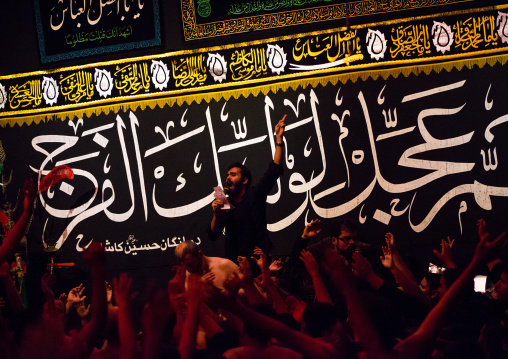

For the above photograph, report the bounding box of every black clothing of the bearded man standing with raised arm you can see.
[208,162,284,262]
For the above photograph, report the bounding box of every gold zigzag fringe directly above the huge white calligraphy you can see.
[0,54,508,127]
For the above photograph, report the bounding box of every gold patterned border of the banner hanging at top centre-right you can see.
[181,0,474,41]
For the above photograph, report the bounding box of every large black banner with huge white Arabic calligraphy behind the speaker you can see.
[0,61,508,269]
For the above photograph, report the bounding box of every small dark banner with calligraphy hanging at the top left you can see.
[35,0,161,63]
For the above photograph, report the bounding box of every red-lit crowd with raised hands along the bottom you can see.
[0,182,508,359]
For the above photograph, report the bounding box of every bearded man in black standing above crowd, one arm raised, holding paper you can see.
[208,116,285,261]
